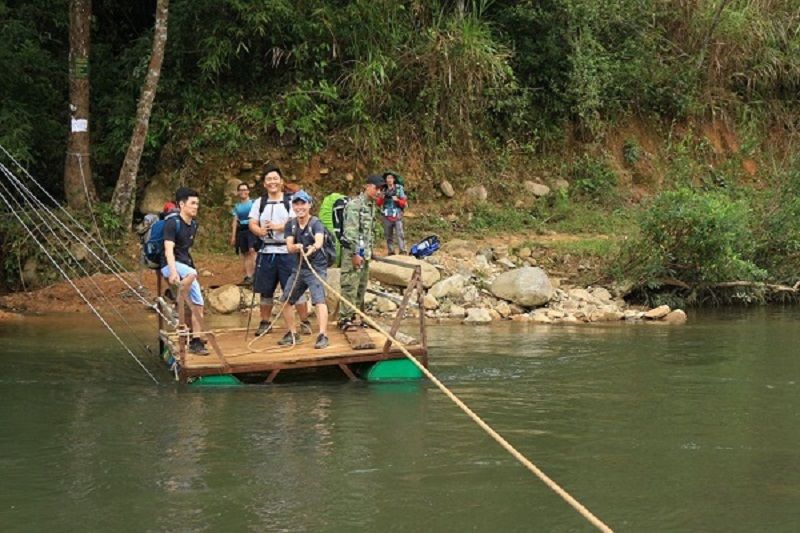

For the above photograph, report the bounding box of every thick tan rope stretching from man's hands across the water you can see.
[301,253,613,533]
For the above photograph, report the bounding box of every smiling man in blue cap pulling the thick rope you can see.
[278,191,328,349]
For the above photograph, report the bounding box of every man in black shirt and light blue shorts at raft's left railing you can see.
[161,187,209,355]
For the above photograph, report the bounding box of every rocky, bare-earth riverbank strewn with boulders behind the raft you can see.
[0,234,686,324]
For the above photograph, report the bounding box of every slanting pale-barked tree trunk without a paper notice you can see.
[111,0,169,227]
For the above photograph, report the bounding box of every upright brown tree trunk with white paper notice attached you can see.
[64,0,97,210]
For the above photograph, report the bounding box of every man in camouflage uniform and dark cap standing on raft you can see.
[339,176,386,330]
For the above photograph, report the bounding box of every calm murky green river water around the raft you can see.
[0,308,800,532]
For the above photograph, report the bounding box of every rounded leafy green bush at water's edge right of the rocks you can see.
[621,187,767,285]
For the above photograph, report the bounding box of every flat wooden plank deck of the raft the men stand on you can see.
[161,328,428,383]
